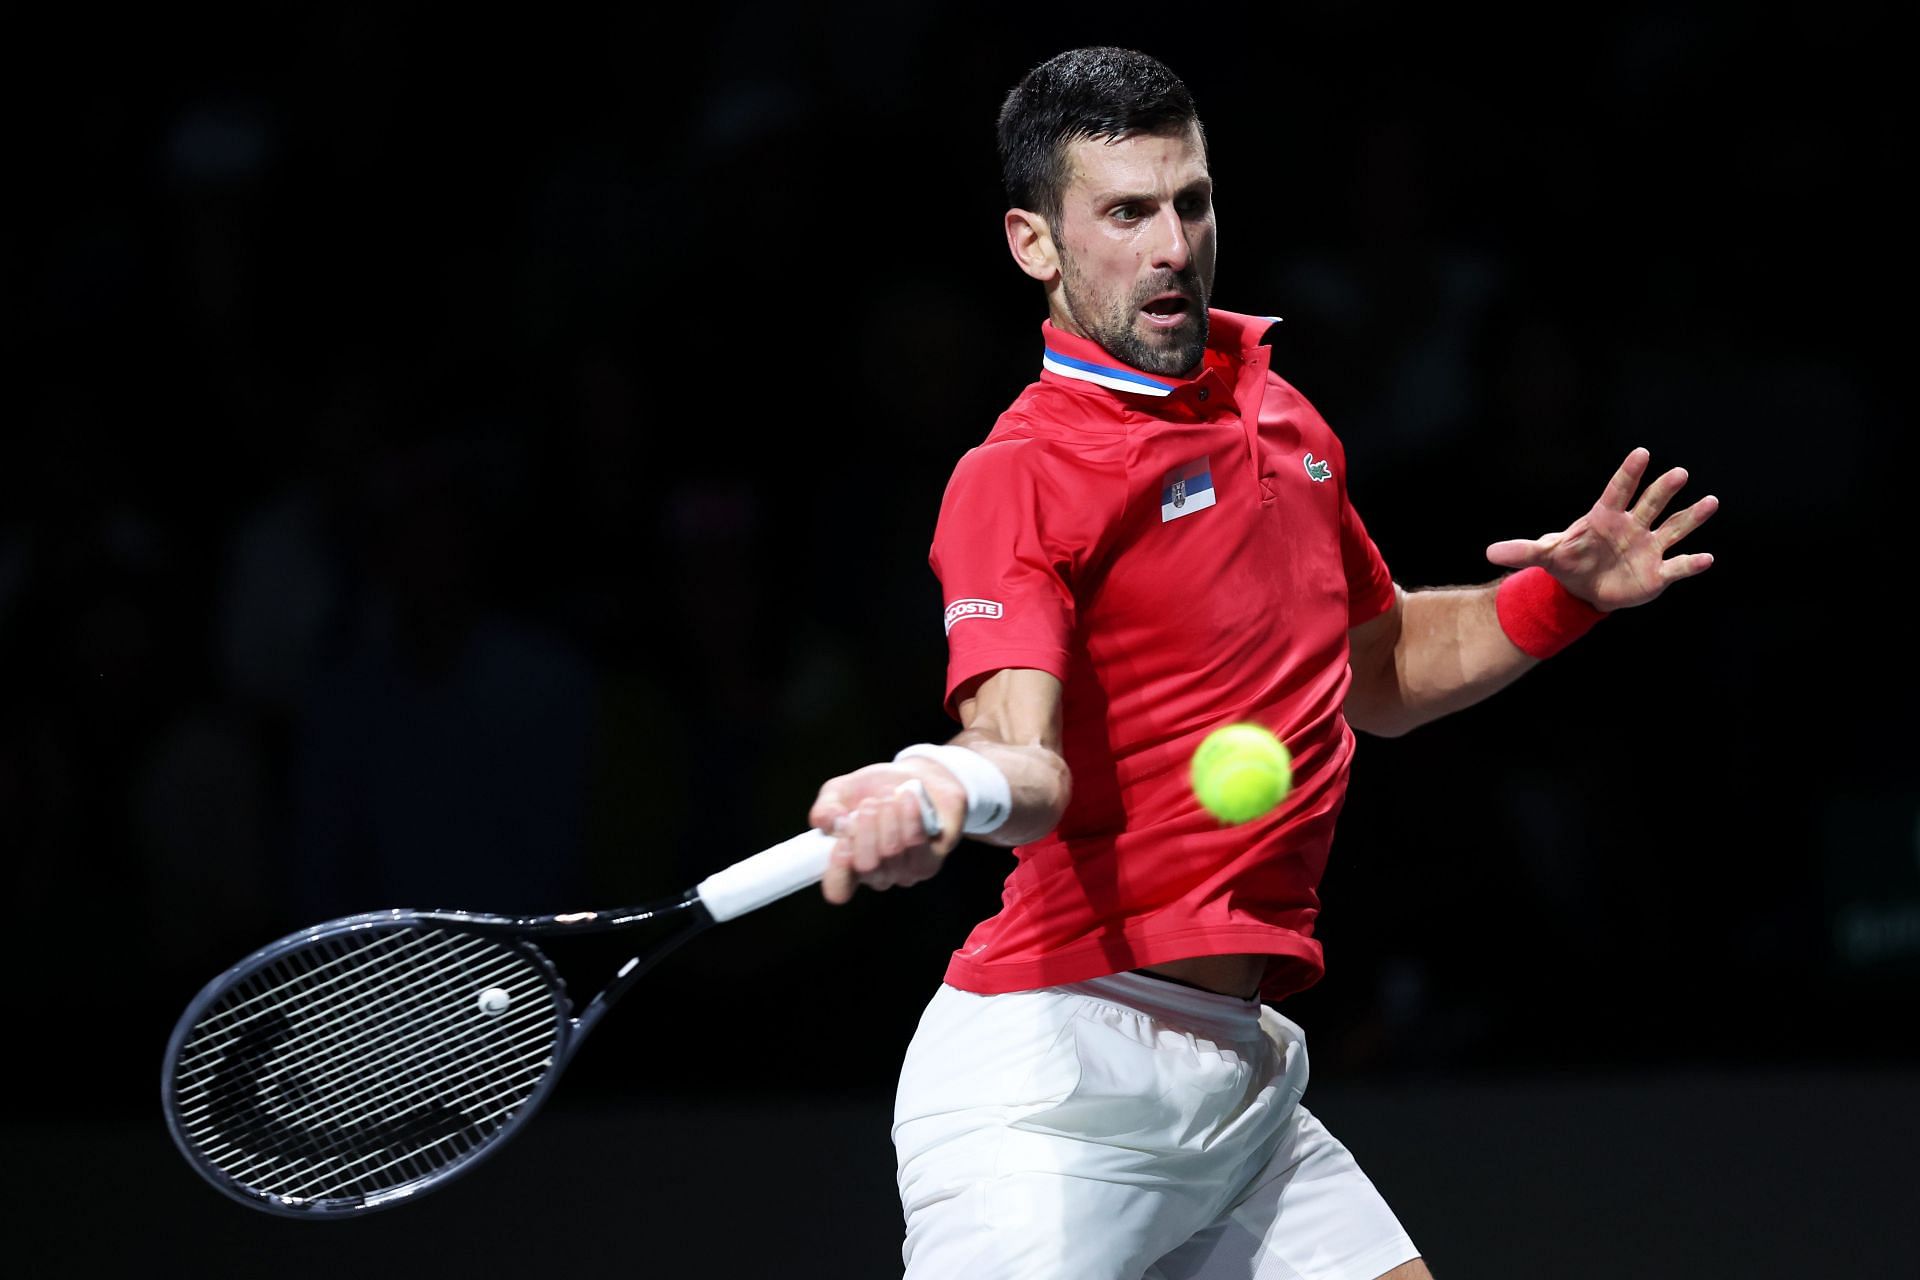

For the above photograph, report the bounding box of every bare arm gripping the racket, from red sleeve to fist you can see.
[808,668,1071,902]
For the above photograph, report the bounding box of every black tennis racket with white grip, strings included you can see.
[161,783,939,1219]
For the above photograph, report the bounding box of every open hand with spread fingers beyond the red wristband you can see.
[1486,449,1720,610]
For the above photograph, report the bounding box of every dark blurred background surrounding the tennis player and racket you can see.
[0,4,1920,1276]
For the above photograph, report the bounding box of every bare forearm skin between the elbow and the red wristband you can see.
[1365,583,1538,737]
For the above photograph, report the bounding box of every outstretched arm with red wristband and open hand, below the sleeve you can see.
[1346,449,1720,737]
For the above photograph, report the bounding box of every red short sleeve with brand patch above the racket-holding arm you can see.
[929,439,1096,718]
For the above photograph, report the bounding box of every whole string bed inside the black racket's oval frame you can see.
[175,927,564,1201]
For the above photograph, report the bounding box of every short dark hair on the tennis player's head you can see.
[1000,46,1206,223]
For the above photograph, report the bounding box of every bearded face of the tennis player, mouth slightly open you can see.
[1054,127,1215,376]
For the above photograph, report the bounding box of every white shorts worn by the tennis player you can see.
[893,973,1419,1280]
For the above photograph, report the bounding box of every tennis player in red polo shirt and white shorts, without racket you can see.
[810,48,1716,1280]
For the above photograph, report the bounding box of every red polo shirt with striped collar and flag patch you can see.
[931,311,1394,1000]
